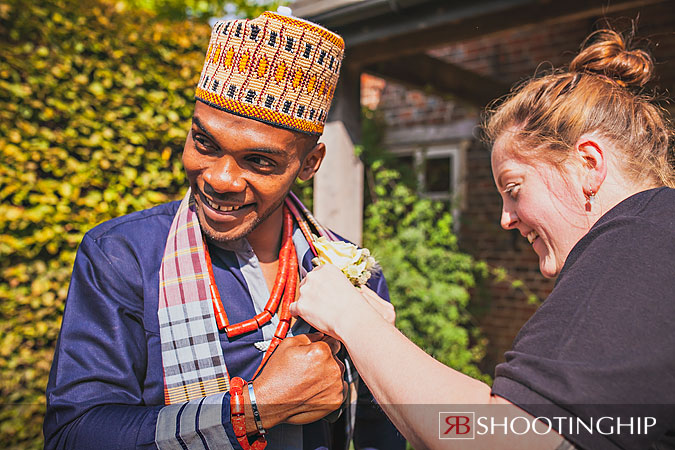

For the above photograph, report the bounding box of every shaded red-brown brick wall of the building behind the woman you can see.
[362,3,675,372]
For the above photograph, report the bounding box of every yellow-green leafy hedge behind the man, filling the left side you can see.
[0,0,210,449]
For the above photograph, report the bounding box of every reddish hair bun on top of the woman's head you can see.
[570,30,654,86]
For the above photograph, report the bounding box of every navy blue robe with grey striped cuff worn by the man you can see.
[44,202,405,450]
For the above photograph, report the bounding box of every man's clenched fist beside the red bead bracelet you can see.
[252,333,347,431]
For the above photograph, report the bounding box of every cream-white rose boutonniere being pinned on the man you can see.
[312,236,377,287]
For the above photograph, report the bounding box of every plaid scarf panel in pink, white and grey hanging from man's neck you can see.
[157,189,230,405]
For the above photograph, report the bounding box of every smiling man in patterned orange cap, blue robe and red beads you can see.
[44,13,404,449]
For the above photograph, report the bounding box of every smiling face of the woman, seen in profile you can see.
[492,136,590,278]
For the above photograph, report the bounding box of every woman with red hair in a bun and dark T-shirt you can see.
[293,30,675,449]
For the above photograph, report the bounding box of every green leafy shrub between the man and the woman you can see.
[357,108,499,383]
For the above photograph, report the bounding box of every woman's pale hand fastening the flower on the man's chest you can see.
[290,264,395,339]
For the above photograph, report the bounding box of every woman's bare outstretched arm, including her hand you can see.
[291,265,562,449]
